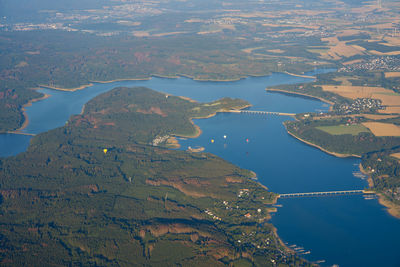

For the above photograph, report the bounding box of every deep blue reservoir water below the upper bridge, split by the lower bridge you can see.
[180,114,400,266]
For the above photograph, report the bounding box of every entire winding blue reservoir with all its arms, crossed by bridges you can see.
[0,73,400,266]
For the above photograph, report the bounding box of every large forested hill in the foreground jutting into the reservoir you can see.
[0,88,306,266]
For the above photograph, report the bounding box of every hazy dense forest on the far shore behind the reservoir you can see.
[0,27,332,132]
